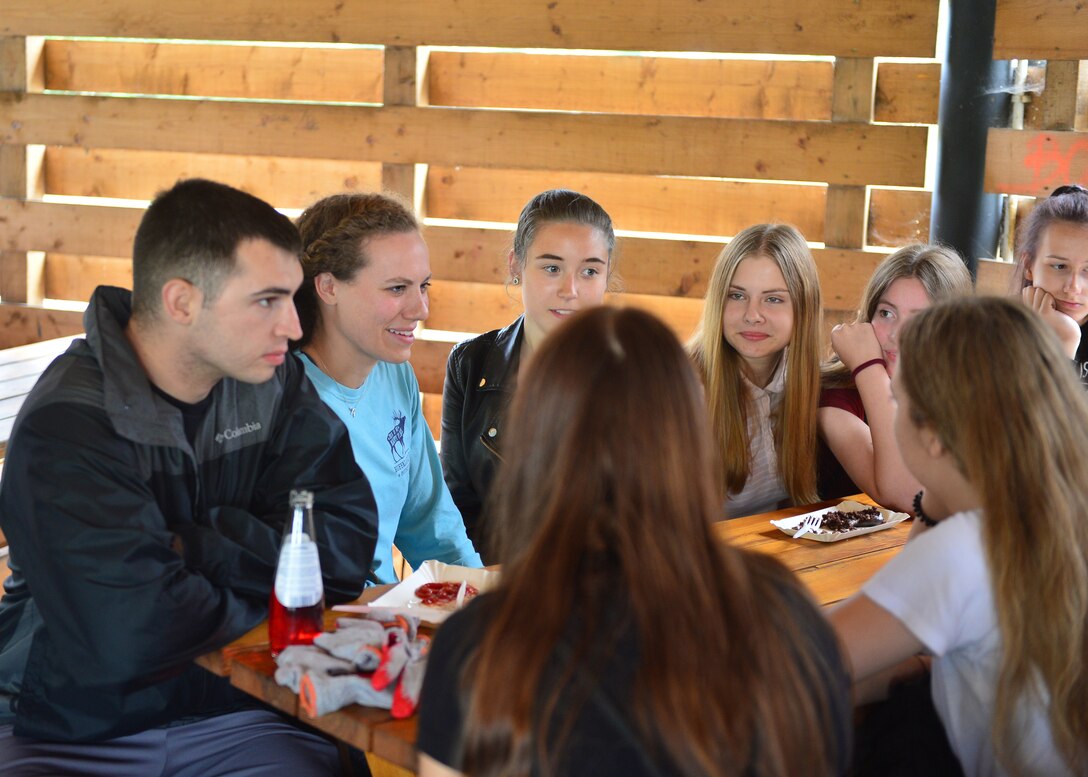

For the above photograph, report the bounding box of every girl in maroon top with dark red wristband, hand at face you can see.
[816,243,972,510]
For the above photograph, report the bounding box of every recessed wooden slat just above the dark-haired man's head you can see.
[45,146,382,208]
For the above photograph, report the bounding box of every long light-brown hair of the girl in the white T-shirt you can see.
[900,297,1088,774]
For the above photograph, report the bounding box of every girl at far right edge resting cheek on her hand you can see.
[1012,184,1088,385]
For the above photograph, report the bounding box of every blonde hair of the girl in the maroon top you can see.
[820,243,974,389]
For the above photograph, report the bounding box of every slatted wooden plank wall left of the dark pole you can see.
[0,0,970,435]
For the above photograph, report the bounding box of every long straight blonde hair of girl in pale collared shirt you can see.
[688,224,823,504]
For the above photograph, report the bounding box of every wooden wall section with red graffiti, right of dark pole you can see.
[985,0,1088,291]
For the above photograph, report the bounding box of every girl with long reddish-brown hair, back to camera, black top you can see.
[419,307,850,777]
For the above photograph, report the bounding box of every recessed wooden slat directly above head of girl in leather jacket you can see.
[424,165,826,242]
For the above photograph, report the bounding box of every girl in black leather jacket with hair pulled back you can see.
[442,189,616,564]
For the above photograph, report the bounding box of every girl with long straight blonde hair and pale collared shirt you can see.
[689,224,821,518]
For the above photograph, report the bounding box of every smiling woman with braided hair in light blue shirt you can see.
[295,194,481,583]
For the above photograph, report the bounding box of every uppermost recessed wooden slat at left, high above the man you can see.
[44,40,382,102]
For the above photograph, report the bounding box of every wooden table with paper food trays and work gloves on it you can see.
[198,497,911,775]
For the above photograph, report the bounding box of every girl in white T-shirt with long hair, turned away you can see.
[831,297,1088,777]
